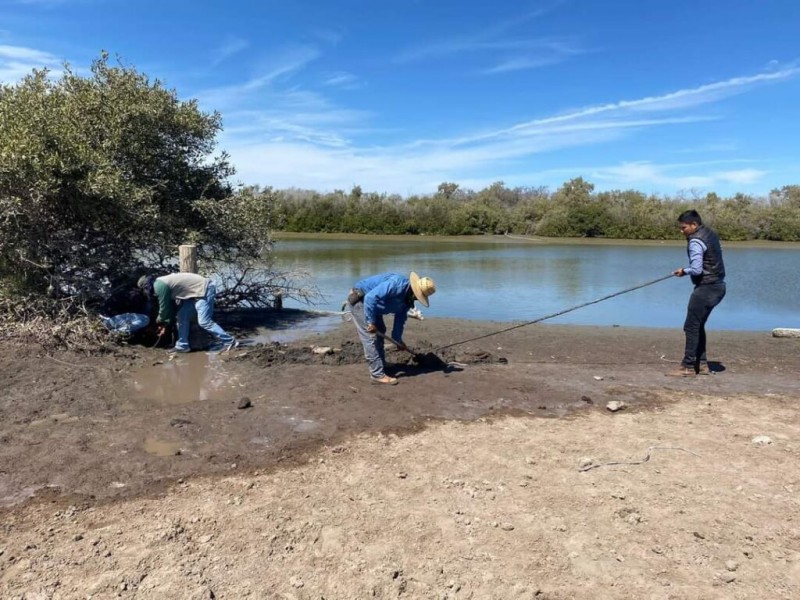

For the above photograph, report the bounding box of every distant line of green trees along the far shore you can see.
[272,177,800,241]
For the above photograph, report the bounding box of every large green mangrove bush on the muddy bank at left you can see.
[0,54,296,346]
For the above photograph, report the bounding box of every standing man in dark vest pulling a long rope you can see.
[671,210,725,377]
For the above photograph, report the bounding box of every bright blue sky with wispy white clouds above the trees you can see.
[0,0,800,195]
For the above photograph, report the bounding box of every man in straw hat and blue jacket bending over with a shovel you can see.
[347,272,436,385]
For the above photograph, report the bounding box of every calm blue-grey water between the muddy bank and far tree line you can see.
[275,237,800,330]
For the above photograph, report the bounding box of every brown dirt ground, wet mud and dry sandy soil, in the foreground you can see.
[0,312,800,600]
